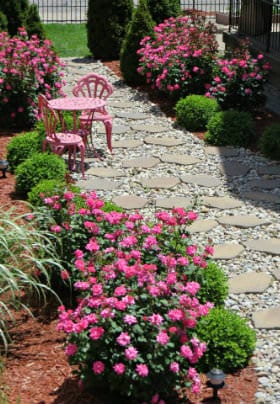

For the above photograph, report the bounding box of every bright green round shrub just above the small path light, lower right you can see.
[196,307,256,373]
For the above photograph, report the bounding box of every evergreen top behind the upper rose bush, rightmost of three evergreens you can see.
[147,0,181,25]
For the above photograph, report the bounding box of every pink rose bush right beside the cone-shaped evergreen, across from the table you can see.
[137,14,218,98]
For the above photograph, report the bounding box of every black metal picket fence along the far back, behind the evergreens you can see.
[29,0,230,23]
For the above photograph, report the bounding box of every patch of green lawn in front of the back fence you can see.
[44,24,90,57]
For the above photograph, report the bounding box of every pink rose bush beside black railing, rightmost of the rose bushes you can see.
[206,41,271,111]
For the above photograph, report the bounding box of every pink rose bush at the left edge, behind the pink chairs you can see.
[0,28,63,129]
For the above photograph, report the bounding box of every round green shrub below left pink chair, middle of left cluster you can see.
[15,153,66,196]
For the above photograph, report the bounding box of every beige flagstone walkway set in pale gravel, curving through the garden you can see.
[62,59,280,403]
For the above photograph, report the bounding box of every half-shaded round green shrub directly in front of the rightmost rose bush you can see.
[205,109,255,147]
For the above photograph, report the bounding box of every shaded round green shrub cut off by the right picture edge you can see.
[259,123,280,160]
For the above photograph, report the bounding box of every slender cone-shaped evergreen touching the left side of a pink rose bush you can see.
[120,0,155,84]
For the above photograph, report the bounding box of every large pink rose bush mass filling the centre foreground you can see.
[32,192,217,402]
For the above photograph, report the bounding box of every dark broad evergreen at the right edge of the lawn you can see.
[87,0,133,60]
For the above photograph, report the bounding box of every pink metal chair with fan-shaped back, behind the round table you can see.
[72,73,114,153]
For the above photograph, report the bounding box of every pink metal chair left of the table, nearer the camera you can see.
[38,94,85,178]
